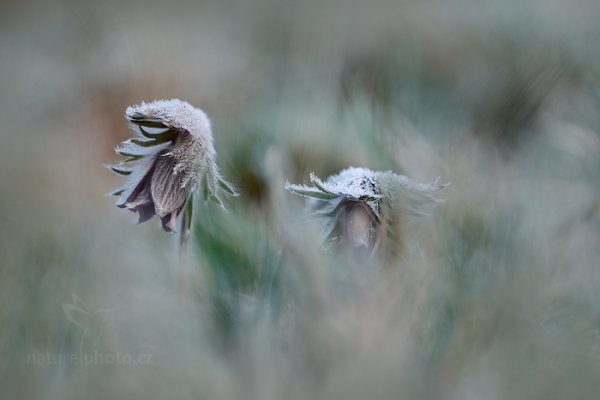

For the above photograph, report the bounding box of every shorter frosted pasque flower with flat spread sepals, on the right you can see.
[285,167,448,255]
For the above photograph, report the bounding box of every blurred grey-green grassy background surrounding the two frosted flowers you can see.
[0,0,600,399]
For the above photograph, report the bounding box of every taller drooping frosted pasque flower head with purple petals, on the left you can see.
[110,99,237,232]
